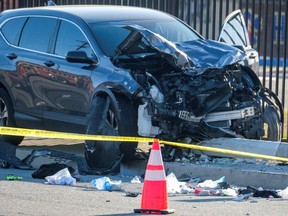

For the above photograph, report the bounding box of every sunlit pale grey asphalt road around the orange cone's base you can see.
[0,174,288,216]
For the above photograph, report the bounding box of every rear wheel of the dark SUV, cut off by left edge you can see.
[0,88,24,145]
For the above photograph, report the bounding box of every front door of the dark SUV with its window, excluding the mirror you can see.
[41,20,95,132]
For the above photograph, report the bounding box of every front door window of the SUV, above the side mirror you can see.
[55,21,94,58]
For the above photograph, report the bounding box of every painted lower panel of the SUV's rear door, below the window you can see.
[1,47,45,128]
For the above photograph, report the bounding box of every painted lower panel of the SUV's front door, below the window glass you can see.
[41,57,92,130]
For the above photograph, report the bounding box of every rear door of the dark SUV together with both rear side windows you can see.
[3,16,57,128]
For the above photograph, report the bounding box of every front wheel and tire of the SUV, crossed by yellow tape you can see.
[85,96,137,169]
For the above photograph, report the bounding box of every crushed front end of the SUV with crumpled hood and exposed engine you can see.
[113,26,281,141]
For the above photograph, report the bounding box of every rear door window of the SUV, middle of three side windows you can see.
[19,17,57,52]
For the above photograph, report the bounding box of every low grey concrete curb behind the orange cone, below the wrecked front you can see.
[121,161,288,190]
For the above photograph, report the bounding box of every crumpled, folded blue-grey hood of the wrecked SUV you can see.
[113,25,245,75]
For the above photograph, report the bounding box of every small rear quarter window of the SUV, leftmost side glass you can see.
[1,17,27,45]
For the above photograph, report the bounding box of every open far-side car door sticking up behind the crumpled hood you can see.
[218,10,259,72]
